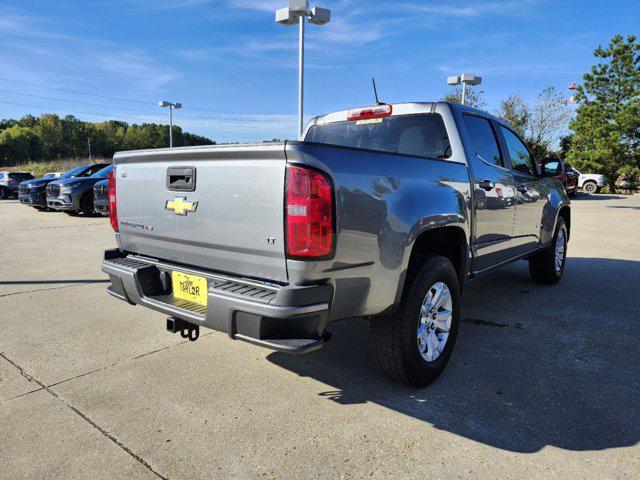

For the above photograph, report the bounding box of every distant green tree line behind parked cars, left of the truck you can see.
[0,114,215,166]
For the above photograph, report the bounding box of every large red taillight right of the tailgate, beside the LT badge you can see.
[285,165,334,259]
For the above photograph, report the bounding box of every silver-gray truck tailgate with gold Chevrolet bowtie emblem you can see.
[115,144,287,282]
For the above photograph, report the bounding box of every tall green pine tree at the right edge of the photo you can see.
[569,35,640,192]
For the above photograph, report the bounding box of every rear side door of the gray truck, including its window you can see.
[463,114,516,272]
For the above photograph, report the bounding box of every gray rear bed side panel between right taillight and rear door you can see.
[286,143,471,320]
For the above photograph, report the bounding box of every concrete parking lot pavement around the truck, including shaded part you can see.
[0,195,640,479]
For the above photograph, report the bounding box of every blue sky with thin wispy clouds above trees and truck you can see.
[0,0,640,141]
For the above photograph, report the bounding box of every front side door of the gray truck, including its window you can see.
[500,125,549,255]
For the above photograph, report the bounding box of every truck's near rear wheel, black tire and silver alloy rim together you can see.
[370,256,460,388]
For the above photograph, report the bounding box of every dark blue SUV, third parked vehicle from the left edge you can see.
[47,163,112,215]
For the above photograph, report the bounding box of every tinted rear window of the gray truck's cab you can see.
[306,114,451,159]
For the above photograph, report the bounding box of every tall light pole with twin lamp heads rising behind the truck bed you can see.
[276,0,331,140]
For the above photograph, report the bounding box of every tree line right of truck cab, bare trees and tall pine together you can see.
[444,35,640,192]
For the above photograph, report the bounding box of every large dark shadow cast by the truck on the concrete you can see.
[268,258,640,453]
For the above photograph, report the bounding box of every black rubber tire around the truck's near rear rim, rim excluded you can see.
[369,255,460,388]
